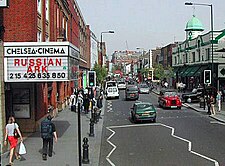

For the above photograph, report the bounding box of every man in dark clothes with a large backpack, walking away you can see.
[41,113,58,160]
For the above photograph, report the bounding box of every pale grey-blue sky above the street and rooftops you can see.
[77,0,225,55]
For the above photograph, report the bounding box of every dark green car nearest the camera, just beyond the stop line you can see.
[131,102,156,123]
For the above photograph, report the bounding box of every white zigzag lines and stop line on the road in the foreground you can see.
[106,123,219,166]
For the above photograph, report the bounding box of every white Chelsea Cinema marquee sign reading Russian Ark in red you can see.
[4,42,79,82]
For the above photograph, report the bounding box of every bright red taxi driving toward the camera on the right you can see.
[158,90,182,109]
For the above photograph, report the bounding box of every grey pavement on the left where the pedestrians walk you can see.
[2,100,105,166]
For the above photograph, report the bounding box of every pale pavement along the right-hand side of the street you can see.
[152,88,225,123]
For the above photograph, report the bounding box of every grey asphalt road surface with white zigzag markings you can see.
[99,91,225,166]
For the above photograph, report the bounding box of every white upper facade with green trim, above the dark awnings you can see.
[172,31,225,67]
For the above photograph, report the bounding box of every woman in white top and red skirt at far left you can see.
[4,116,23,165]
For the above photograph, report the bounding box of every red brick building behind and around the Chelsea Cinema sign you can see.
[0,0,90,151]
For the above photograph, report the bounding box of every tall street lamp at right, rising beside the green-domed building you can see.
[185,2,214,86]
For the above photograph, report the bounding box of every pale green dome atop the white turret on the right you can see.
[185,15,204,31]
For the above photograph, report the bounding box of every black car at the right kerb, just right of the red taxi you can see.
[182,88,204,102]
